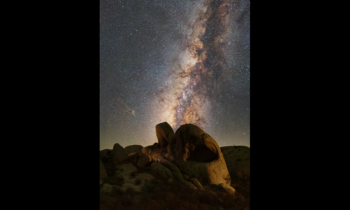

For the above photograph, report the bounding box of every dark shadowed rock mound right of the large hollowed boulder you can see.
[221,146,250,177]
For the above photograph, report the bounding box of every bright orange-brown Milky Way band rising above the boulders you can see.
[157,0,231,130]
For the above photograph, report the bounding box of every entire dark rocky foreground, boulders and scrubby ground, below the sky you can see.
[100,122,250,210]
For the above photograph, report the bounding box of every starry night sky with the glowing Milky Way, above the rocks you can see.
[100,0,250,150]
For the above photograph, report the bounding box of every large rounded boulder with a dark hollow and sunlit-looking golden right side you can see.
[174,124,231,185]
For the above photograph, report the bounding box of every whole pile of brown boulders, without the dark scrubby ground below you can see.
[100,122,243,193]
